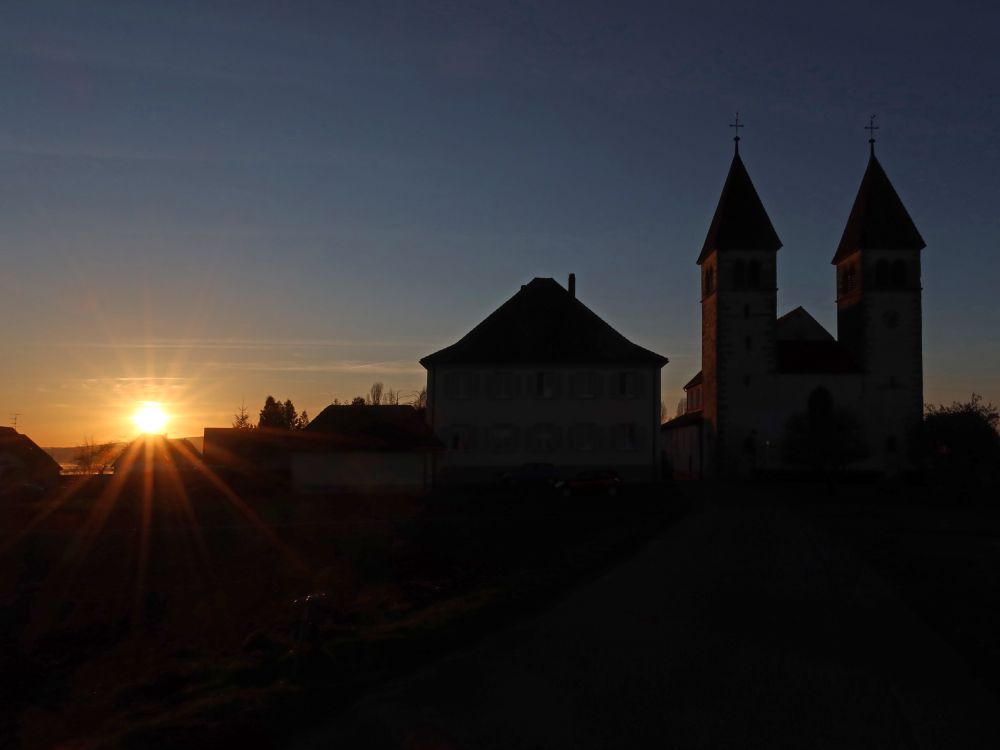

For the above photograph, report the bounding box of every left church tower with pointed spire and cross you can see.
[698,133,781,475]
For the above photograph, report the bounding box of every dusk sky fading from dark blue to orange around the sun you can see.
[0,0,1000,446]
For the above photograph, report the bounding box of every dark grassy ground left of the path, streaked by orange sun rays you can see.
[0,477,685,747]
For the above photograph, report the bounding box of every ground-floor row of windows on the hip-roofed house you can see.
[448,422,642,453]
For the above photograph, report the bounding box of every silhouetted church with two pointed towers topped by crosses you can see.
[661,128,924,478]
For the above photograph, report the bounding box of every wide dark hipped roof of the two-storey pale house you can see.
[420,279,667,367]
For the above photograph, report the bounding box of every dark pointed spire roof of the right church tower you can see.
[832,151,926,263]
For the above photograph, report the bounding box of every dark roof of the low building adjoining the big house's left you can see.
[304,405,443,451]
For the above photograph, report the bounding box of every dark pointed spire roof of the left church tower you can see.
[698,153,781,265]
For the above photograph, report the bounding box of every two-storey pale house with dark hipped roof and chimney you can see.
[420,274,667,482]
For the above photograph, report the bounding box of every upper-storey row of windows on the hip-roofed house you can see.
[444,370,644,399]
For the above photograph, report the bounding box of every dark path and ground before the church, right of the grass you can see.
[295,486,1000,748]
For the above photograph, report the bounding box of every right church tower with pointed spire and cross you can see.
[832,131,925,463]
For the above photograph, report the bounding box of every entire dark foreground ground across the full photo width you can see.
[0,484,1000,748]
